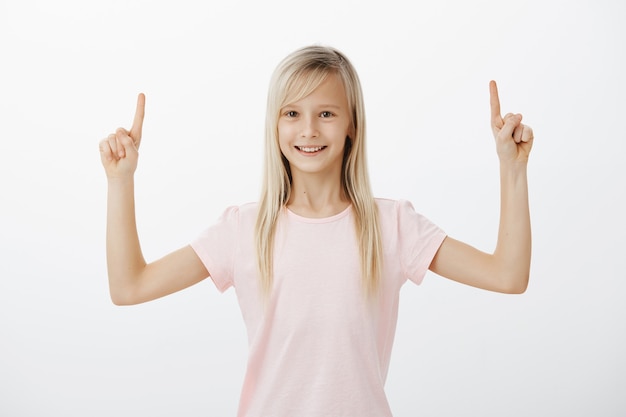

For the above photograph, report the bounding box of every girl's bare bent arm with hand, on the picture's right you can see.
[430,81,533,294]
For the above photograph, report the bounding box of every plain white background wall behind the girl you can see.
[0,0,626,417]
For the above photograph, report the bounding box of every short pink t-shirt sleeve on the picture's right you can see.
[396,200,446,284]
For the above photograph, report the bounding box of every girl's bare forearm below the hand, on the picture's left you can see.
[106,177,146,303]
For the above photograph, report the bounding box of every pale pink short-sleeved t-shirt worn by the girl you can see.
[192,199,445,417]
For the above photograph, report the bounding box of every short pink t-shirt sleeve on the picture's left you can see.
[191,207,239,292]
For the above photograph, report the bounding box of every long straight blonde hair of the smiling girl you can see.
[255,46,382,295]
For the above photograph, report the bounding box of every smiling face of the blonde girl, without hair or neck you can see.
[278,74,352,180]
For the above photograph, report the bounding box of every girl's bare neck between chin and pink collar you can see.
[287,174,350,218]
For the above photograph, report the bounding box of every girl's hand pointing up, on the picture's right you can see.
[489,81,533,163]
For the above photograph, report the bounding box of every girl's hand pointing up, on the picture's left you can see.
[100,94,146,178]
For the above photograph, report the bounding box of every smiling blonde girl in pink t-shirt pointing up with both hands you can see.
[100,46,533,417]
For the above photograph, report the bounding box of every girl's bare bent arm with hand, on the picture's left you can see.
[100,94,209,305]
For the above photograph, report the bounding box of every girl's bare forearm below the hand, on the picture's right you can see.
[494,163,532,292]
